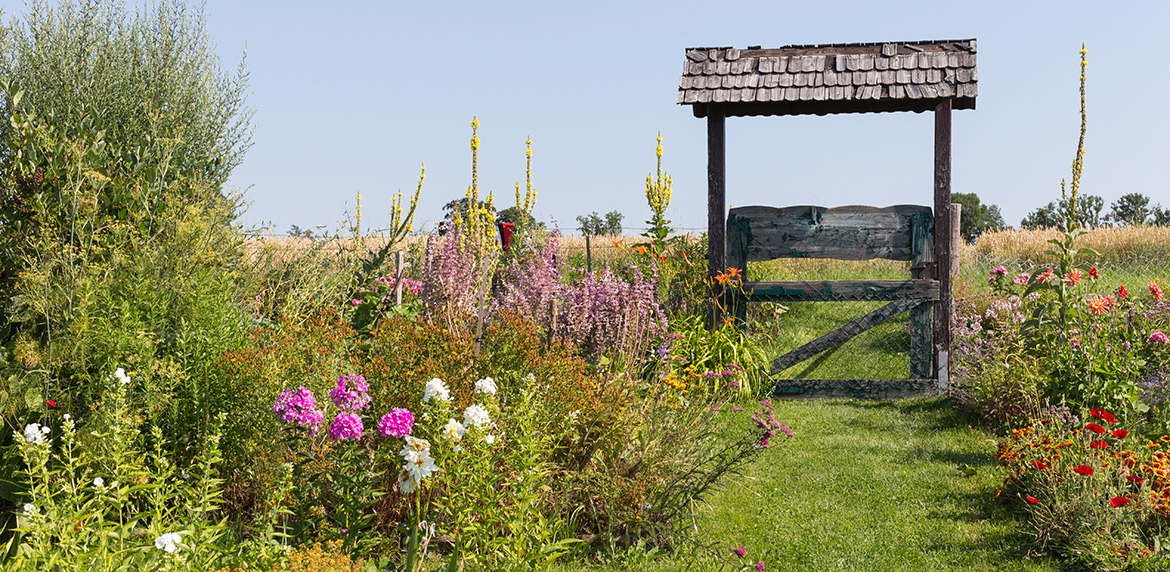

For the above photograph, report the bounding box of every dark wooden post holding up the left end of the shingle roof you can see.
[707,105,727,328]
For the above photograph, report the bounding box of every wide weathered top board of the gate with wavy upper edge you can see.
[728,205,930,261]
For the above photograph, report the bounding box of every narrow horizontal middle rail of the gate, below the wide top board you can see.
[744,277,938,302]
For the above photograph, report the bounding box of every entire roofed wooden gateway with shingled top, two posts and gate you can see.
[677,39,978,398]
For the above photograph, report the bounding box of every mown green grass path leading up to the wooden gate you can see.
[563,398,1059,572]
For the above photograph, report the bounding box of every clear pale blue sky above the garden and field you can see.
[11,0,1170,233]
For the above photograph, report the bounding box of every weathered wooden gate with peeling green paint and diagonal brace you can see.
[724,205,940,398]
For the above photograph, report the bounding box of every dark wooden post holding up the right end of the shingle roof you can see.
[934,99,952,385]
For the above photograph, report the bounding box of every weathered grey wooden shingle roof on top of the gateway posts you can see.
[679,40,978,117]
